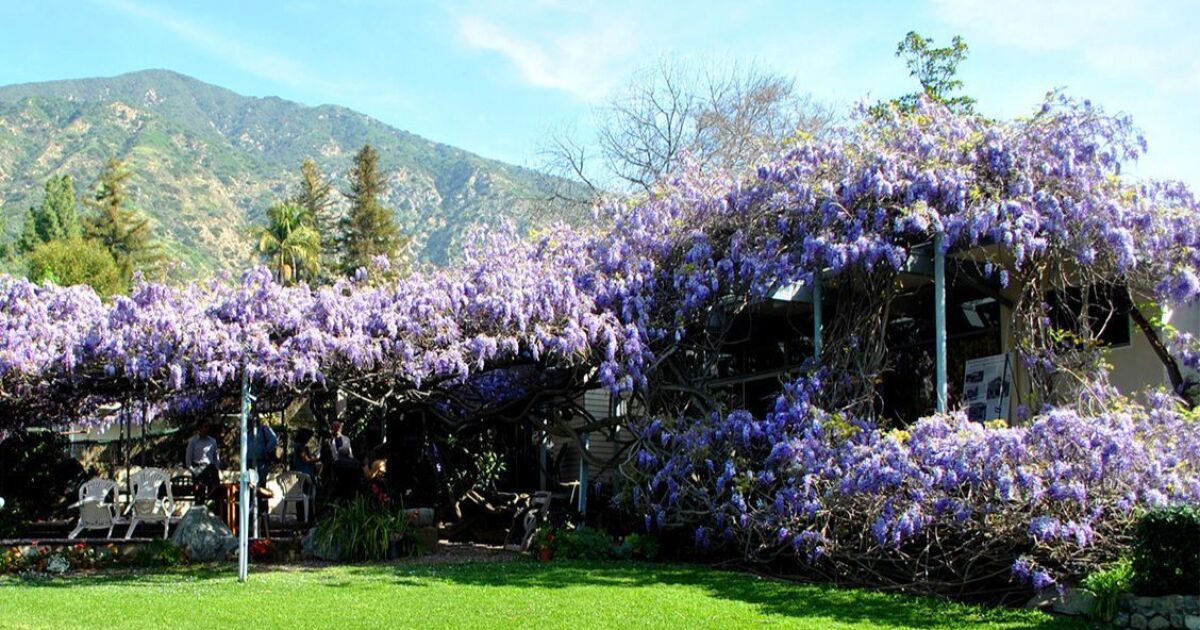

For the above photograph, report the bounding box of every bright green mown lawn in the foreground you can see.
[0,560,1076,630]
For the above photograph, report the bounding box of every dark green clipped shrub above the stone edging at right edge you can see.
[1133,505,1200,595]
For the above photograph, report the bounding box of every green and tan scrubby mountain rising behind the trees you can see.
[0,70,554,274]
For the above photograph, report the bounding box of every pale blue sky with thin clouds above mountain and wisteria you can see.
[0,0,1200,187]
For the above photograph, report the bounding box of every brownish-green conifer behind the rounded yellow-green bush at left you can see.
[84,158,160,278]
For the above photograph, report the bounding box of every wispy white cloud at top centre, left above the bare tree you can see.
[457,0,641,101]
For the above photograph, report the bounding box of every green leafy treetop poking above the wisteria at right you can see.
[895,31,976,113]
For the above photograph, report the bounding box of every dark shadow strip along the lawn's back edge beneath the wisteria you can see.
[0,560,1087,630]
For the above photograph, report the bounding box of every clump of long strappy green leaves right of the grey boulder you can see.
[314,497,409,562]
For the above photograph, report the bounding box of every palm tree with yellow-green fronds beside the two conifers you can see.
[258,203,320,284]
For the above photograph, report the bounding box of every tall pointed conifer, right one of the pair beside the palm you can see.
[341,144,403,274]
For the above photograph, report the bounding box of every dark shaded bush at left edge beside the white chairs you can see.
[0,431,86,538]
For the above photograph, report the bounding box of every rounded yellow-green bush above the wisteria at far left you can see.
[26,238,128,296]
